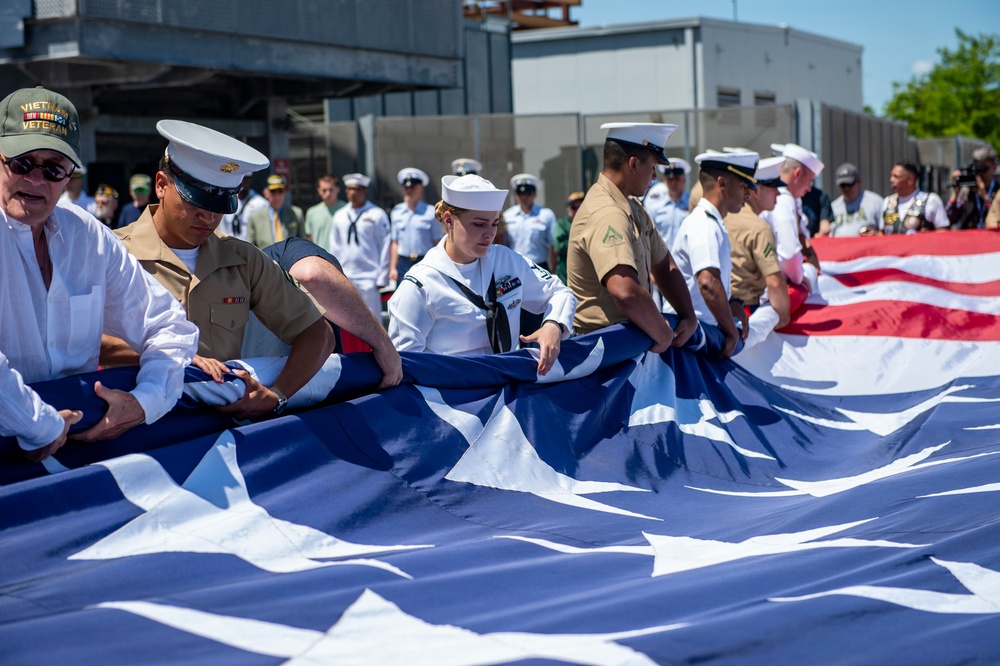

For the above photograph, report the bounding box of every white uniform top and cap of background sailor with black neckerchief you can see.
[329,174,391,316]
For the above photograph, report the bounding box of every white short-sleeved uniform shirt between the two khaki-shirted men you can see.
[670,197,733,325]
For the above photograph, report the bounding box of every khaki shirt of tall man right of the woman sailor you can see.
[566,174,667,333]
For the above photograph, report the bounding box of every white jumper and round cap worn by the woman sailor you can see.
[389,175,576,356]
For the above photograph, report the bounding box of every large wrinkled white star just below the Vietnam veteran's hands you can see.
[69,430,432,578]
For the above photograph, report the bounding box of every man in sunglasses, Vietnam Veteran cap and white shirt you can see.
[0,87,198,462]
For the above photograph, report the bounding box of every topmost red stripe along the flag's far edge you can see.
[812,229,1000,262]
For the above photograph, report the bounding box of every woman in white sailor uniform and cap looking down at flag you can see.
[389,175,576,374]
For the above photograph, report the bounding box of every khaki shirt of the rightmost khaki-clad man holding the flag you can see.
[726,204,781,305]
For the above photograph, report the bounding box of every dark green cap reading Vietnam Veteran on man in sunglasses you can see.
[0,86,83,167]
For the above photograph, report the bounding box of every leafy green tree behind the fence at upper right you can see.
[883,28,1000,149]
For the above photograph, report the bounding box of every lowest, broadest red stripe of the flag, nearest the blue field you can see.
[780,301,1000,340]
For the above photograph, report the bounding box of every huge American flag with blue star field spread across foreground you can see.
[0,232,1000,665]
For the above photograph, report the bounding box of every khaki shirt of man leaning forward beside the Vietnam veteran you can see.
[115,205,323,361]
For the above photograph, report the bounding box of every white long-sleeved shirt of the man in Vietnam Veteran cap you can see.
[0,203,198,450]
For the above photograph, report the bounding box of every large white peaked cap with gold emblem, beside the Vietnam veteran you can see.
[156,120,270,189]
